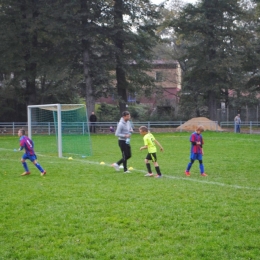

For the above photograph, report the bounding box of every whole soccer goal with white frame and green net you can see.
[27,104,92,157]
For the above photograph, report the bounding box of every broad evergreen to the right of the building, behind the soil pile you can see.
[168,0,249,120]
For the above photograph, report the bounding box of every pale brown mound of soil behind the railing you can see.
[177,117,223,131]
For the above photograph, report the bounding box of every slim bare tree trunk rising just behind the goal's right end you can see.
[83,50,96,118]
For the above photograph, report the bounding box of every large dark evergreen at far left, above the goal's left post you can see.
[0,0,80,121]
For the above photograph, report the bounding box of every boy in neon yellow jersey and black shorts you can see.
[139,126,163,178]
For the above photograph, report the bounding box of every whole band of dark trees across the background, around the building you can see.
[0,0,260,121]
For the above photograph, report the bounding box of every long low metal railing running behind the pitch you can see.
[0,121,260,135]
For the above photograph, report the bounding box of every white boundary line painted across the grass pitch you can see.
[0,148,260,191]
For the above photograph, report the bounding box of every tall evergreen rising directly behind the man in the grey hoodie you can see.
[112,0,159,112]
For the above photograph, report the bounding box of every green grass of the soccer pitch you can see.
[0,132,260,260]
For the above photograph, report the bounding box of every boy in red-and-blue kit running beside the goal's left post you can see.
[18,129,46,176]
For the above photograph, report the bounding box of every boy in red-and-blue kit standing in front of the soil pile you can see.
[185,126,207,176]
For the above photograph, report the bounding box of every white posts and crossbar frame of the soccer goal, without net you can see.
[27,104,84,158]
